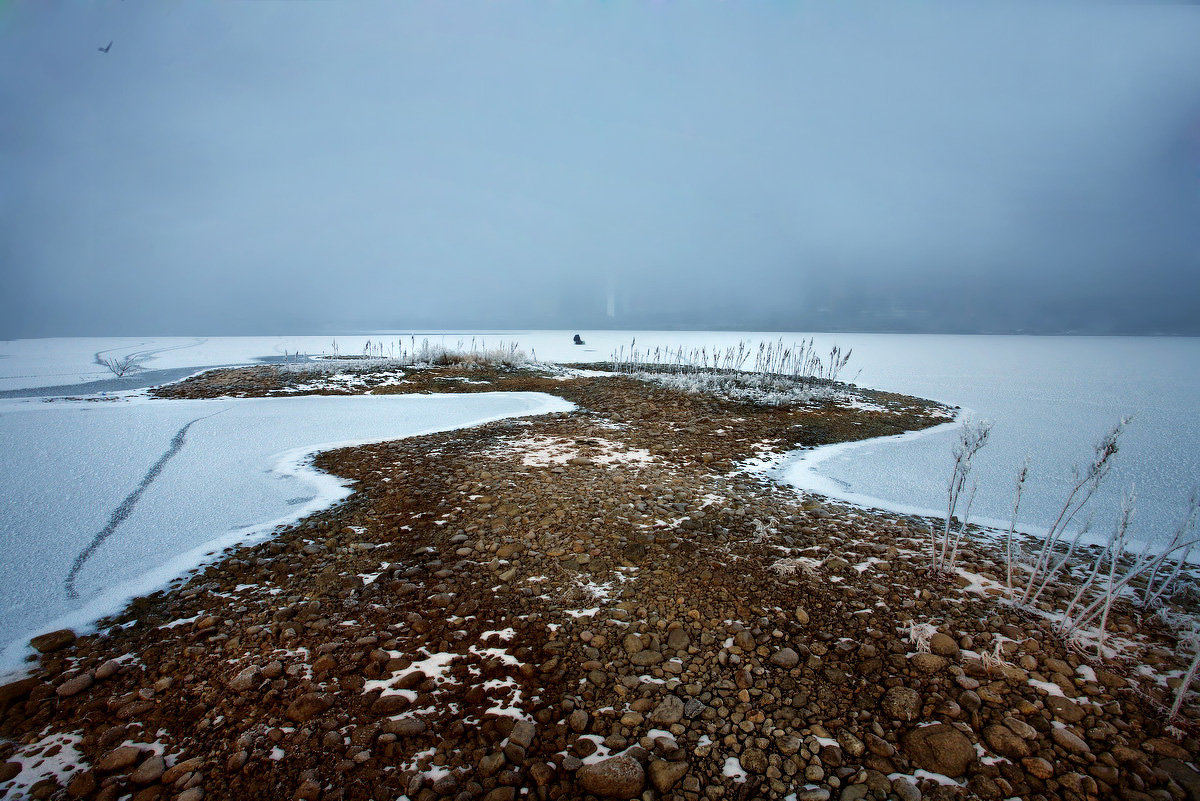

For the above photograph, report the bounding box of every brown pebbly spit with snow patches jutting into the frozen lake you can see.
[0,367,1200,801]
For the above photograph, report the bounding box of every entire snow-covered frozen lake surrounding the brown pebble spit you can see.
[0,331,1200,667]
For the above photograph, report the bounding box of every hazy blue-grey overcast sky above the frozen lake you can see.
[0,0,1200,338]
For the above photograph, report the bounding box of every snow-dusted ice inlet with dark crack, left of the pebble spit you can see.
[0,393,572,670]
